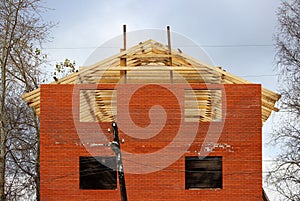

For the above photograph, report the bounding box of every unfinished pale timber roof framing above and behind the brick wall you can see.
[22,40,280,122]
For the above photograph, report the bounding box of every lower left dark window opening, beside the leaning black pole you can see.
[79,156,117,189]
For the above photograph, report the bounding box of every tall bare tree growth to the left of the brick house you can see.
[0,0,52,201]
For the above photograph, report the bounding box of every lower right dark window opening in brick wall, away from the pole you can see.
[185,156,222,189]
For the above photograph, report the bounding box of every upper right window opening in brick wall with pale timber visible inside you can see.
[184,89,222,122]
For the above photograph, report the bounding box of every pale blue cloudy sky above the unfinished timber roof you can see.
[43,0,280,198]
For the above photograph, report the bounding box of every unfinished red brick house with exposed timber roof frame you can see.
[23,35,279,201]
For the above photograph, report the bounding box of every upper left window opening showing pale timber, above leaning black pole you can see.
[79,89,117,122]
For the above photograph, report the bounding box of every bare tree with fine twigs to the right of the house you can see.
[267,0,300,201]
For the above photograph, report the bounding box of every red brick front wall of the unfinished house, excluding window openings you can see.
[40,84,262,201]
